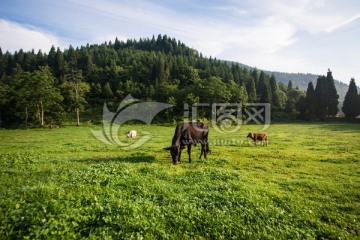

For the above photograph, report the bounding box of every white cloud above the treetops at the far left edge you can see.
[0,19,60,52]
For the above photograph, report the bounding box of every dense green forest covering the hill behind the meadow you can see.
[0,35,358,126]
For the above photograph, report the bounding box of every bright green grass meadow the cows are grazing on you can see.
[0,123,360,239]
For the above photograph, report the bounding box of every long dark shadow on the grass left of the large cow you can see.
[73,153,155,163]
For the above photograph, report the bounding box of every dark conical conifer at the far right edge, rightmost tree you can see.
[342,78,360,120]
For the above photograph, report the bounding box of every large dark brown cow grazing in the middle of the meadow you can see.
[164,122,210,164]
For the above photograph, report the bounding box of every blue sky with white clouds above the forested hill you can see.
[0,0,360,86]
